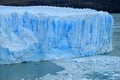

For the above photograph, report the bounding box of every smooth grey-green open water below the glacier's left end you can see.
[0,61,64,80]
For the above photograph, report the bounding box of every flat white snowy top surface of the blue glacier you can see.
[0,6,107,17]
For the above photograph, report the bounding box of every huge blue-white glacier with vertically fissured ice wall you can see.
[0,6,113,64]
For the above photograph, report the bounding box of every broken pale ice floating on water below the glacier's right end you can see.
[39,55,120,80]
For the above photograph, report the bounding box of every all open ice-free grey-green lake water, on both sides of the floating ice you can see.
[0,14,120,80]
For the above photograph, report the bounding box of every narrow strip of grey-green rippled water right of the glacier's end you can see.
[108,14,120,56]
